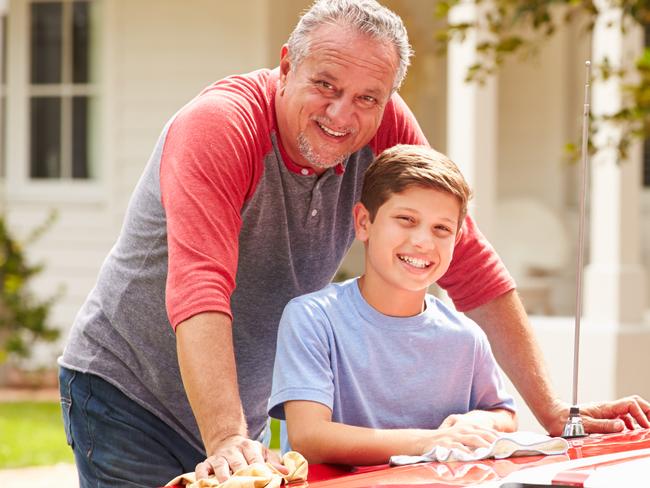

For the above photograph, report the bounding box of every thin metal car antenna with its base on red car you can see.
[562,61,591,438]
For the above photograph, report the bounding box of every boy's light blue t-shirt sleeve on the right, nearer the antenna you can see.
[470,330,516,412]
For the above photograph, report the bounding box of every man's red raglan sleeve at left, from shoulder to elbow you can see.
[160,81,270,329]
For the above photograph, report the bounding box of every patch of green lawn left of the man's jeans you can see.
[0,402,74,469]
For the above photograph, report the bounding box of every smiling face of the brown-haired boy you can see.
[354,186,460,297]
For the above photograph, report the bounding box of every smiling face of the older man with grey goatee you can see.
[276,24,398,170]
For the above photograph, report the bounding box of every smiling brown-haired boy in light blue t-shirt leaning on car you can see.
[269,146,516,465]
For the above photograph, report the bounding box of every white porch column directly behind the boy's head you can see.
[447,0,498,238]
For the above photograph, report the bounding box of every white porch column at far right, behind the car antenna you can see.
[584,0,645,324]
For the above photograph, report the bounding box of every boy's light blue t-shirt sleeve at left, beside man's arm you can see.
[268,299,334,420]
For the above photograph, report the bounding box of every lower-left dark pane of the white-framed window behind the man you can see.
[30,97,61,178]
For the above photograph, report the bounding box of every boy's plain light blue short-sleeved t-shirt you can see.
[268,279,514,442]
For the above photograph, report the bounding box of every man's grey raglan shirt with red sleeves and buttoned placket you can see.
[59,68,514,451]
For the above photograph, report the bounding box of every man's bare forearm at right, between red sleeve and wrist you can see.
[467,291,562,429]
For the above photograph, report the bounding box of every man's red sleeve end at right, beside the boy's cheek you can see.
[438,215,515,312]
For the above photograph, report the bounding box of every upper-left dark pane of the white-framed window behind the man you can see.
[31,3,63,83]
